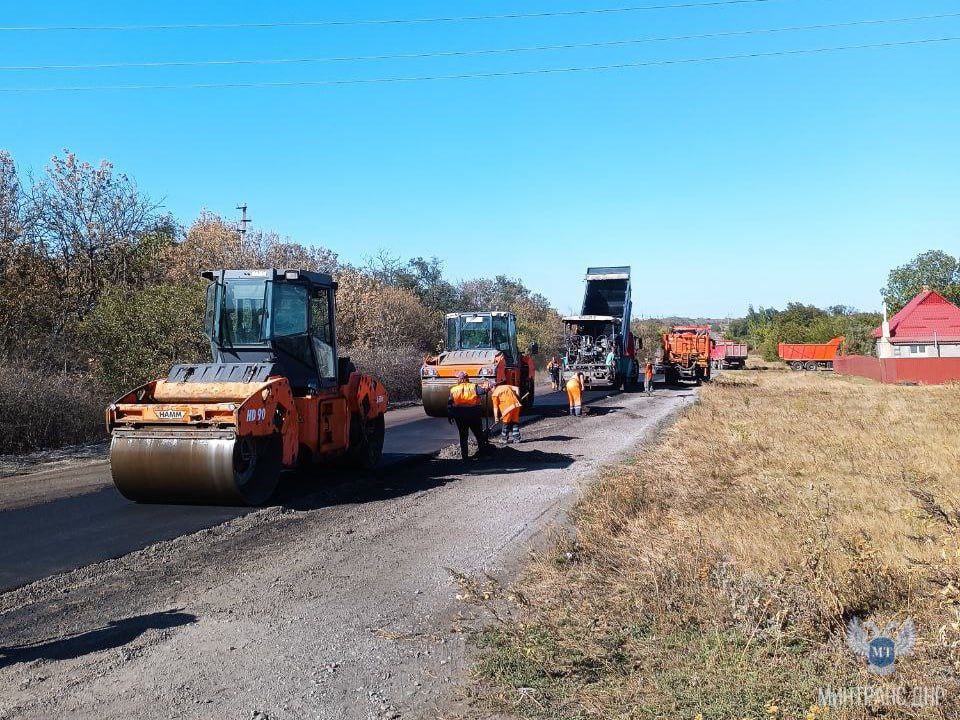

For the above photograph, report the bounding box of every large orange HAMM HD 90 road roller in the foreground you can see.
[107,269,387,505]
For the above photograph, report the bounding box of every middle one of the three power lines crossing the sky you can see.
[0,12,960,72]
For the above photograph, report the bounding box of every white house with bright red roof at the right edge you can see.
[873,288,960,359]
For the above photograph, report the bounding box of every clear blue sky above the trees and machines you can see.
[0,0,960,316]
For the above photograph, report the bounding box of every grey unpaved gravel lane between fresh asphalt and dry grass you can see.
[0,391,694,720]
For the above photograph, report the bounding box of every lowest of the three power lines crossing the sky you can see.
[0,36,960,93]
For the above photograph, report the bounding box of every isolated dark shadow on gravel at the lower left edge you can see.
[0,610,197,668]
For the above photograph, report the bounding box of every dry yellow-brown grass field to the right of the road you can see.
[477,368,960,718]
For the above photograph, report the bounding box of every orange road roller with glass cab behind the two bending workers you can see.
[420,311,537,417]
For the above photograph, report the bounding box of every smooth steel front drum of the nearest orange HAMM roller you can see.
[110,429,282,505]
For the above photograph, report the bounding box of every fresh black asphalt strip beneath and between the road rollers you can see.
[0,390,612,592]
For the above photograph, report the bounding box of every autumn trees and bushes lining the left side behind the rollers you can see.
[0,150,562,453]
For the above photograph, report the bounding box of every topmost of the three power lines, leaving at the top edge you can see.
[0,0,781,32]
